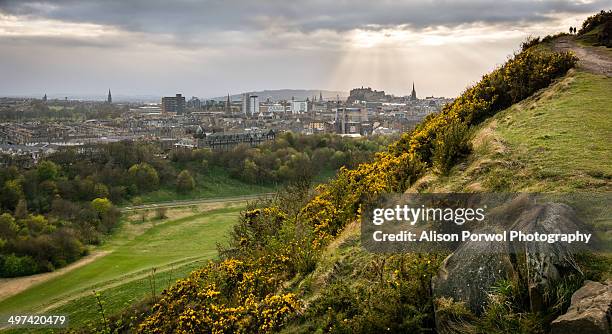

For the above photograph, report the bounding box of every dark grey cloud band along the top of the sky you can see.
[0,0,610,38]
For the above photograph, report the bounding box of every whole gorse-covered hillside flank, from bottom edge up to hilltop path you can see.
[128,35,576,333]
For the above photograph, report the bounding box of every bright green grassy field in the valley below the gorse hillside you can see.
[0,205,243,332]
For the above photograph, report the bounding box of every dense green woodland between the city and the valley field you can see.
[0,133,390,277]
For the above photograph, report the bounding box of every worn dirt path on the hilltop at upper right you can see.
[553,36,612,77]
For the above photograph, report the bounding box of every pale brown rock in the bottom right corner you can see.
[551,280,612,334]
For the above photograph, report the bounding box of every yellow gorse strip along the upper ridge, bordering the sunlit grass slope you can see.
[303,50,577,245]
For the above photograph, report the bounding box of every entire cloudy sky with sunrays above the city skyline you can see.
[0,0,612,98]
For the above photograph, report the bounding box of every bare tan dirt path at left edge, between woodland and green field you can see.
[0,251,110,300]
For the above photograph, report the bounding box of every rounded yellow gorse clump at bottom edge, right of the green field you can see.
[138,259,300,333]
